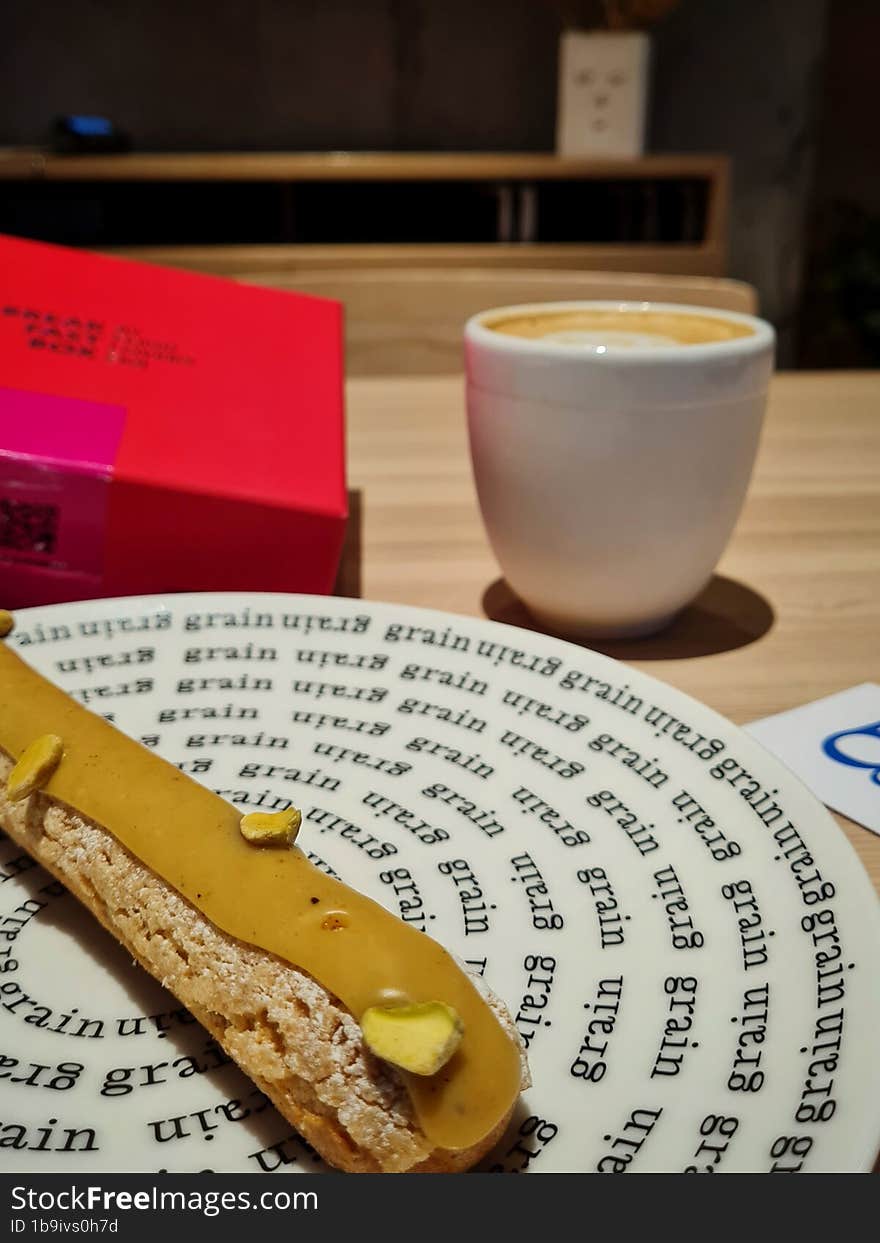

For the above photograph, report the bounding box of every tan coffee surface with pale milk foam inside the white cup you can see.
[484,307,754,349]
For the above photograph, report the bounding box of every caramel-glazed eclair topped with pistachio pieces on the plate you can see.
[0,619,528,1173]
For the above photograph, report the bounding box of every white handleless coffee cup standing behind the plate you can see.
[465,295,774,638]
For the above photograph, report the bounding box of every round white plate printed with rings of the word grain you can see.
[0,593,880,1173]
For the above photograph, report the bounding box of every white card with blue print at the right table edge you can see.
[745,682,880,833]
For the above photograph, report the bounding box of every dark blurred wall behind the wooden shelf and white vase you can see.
[0,0,880,363]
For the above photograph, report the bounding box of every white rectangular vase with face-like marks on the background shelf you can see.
[556,30,650,158]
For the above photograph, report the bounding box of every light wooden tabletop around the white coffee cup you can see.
[348,372,880,890]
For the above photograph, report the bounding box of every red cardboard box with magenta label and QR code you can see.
[0,236,346,608]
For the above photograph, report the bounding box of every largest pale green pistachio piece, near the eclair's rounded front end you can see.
[360,1002,464,1075]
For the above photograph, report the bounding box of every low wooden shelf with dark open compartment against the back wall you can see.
[0,148,728,276]
